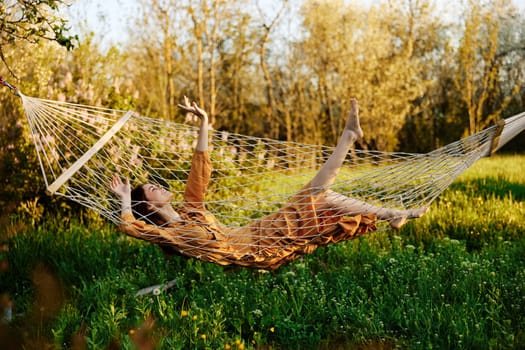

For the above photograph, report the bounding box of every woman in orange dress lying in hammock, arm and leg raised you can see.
[110,98,427,269]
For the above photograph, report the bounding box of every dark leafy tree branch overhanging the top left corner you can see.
[0,0,78,74]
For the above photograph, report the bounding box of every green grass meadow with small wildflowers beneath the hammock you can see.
[0,156,525,349]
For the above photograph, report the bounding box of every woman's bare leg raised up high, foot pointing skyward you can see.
[310,98,363,191]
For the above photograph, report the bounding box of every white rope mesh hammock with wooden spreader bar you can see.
[10,90,525,269]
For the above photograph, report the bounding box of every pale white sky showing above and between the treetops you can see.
[65,0,525,45]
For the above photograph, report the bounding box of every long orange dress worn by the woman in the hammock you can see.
[120,151,377,270]
